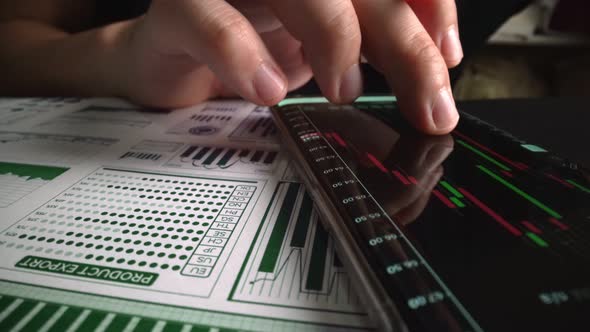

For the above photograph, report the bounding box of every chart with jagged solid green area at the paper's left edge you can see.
[0,162,68,208]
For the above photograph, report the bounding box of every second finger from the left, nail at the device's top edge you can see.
[266,0,362,103]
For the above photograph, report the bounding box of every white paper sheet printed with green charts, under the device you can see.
[0,99,371,331]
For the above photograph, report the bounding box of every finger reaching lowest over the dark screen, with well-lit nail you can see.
[353,0,459,134]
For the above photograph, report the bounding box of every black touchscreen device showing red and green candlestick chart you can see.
[273,96,590,331]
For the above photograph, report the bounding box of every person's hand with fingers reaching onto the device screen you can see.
[119,0,462,134]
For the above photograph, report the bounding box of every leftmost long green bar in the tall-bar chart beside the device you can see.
[258,183,301,273]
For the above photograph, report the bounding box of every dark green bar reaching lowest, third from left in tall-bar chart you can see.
[305,223,328,291]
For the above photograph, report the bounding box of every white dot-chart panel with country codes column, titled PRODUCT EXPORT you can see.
[0,168,258,296]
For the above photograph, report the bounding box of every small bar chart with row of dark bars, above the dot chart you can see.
[166,145,279,173]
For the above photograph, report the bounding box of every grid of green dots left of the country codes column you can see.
[0,170,247,271]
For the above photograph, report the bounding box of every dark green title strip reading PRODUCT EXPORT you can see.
[15,256,158,286]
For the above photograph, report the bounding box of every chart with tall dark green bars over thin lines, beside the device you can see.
[232,182,362,314]
